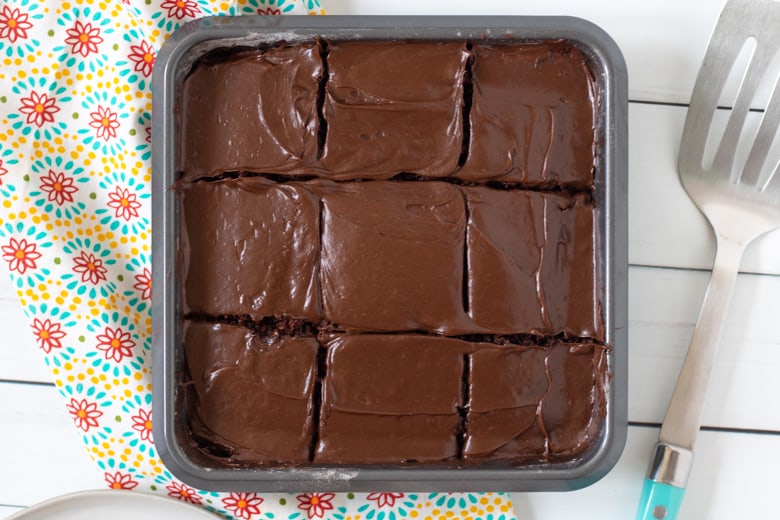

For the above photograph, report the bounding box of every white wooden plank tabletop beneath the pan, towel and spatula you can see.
[0,0,780,520]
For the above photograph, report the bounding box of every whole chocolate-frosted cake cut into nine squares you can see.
[174,36,609,468]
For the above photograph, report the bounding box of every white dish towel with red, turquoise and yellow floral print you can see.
[0,0,515,520]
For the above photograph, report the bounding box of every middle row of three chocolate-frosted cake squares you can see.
[181,177,603,339]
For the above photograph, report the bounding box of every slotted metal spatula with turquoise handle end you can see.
[637,0,780,520]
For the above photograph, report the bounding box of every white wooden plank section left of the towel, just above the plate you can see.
[0,383,106,506]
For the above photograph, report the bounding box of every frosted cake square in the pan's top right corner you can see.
[457,42,596,189]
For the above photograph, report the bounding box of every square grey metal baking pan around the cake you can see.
[152,16,628,492]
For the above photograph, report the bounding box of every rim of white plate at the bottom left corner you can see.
[6,489,217,520]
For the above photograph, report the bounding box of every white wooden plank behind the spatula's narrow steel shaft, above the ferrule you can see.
[629,267,780,431]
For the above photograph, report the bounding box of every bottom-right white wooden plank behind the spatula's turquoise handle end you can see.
[512,427,780,520]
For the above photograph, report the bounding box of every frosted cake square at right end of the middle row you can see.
[464,188,604,339]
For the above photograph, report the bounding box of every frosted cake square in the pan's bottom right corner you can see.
[463,344,606,461]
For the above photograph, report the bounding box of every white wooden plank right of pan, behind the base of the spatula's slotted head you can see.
[628,103,780,274]
